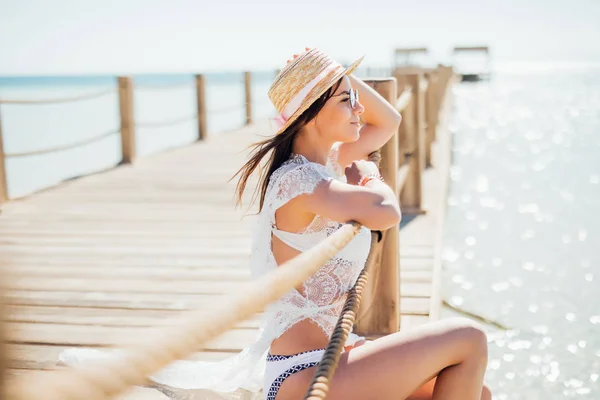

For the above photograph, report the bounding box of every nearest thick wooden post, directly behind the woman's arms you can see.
[356,78,400,337]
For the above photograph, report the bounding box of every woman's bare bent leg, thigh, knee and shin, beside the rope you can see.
[277,318,487,400]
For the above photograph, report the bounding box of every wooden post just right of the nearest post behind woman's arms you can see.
[400,73,425,214]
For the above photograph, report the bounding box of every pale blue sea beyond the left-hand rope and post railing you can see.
[0,71,275,198]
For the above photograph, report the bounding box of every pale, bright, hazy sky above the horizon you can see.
[0,0,600,76]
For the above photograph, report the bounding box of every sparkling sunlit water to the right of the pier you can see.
[443,68,600,400]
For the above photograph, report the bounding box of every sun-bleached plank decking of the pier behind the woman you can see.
[0,105,449,398]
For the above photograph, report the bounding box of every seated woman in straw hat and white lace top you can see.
[61,49,491,400]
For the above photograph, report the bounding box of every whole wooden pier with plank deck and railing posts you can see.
[0,66,453,399]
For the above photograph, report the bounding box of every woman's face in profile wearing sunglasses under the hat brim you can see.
[313,75,365,142]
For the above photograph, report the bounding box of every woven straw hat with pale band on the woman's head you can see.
[268,49,364,135]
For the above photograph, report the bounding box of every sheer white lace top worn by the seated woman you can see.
[60,146,370,400]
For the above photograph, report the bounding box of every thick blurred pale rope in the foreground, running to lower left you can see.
[8,222,361,400]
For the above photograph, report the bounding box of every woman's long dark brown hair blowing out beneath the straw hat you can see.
[231,78,342,214]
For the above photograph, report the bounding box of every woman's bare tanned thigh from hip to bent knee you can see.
[277,319,485,400]
